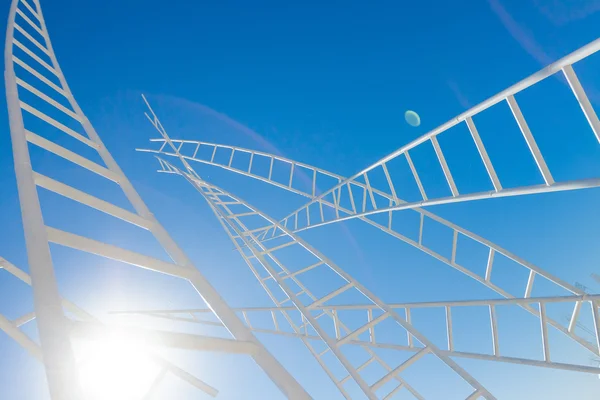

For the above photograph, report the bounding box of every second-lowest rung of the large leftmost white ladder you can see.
[46,226,190,278]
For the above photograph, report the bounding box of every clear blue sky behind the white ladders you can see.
[0,0,600,400]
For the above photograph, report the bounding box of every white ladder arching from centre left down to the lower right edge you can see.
[138,139,598,354]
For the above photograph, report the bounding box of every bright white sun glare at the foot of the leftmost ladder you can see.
[78,335,159,400]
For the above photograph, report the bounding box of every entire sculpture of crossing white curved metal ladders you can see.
[0,0,600,400]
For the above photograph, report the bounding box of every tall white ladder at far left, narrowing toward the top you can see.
[5,0,309,400]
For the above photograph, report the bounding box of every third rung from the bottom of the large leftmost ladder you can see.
[33,172,152,229]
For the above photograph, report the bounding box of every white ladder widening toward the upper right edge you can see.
[240,39,600,228]
